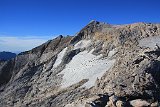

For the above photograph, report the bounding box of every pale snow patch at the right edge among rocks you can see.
[139,36,160,49]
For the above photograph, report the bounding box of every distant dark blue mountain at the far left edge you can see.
[0,51,16,61]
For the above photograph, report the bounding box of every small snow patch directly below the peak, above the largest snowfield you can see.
[74,40,91,49]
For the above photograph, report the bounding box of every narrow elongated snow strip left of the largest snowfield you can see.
[53,47,68,68]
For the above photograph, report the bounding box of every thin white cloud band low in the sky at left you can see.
[0,36,51,52]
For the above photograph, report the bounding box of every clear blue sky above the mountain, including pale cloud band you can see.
[0,0,160,51]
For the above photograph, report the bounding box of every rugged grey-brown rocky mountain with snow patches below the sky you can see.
[0,21,160,107]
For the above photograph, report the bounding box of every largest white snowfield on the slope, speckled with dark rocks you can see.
[59,50,115,88]
